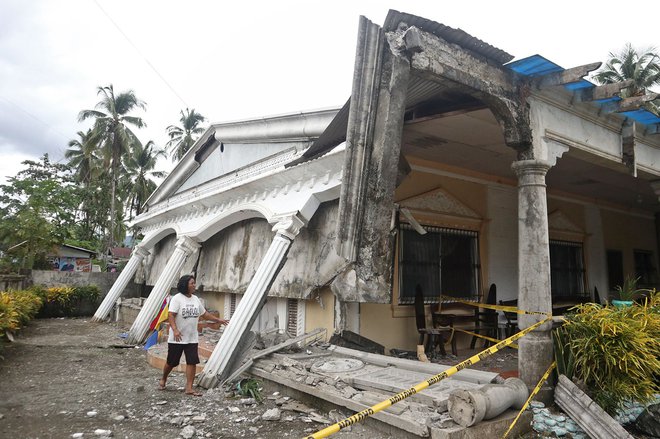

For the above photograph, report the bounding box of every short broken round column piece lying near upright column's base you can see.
[447,378,529,427]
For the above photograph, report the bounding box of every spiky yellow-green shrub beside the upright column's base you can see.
[554,291,660,415]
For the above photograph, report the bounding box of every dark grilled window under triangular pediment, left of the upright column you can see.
[399,224,480,304]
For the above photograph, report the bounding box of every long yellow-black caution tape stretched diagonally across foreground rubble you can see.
[305,317,552,439]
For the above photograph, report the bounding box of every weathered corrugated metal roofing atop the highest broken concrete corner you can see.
[383,9,513,64]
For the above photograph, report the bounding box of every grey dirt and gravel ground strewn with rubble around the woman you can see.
[0,318,532,439]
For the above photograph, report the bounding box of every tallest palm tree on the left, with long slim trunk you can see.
[78,84,146,248]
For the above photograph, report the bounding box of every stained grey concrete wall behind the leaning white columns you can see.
[152,201,345,299]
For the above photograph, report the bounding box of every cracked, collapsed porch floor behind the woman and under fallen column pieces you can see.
[147,329,531,439]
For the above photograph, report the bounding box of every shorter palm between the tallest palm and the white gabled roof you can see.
[125,140,167,220]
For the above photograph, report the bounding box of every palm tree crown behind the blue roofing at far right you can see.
[594,43,660,114]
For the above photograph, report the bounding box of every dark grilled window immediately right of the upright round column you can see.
[550,240,588,298]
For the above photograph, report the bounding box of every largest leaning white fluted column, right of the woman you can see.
[199,215,304,389]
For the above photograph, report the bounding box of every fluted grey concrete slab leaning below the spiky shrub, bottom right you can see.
[555,375,632,439]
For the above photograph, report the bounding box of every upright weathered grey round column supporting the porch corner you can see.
[512,160,553,396]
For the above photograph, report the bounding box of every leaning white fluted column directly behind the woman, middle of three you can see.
[126,236,200,344]
